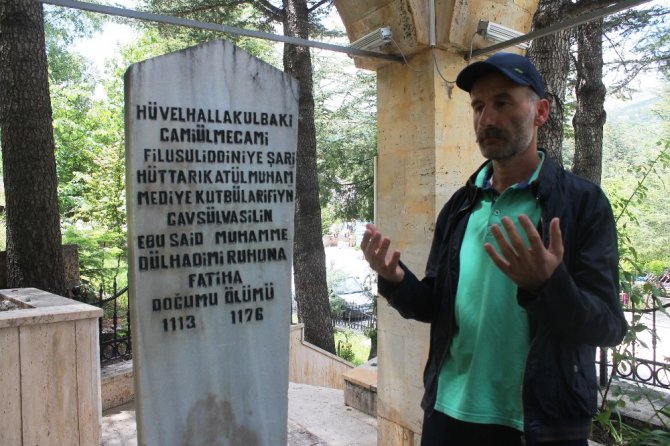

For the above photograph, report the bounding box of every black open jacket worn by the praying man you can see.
[379,151,627,441]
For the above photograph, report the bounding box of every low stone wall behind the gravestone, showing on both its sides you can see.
[101,324,354,410]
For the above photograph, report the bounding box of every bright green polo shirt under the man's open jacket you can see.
[435,152,544,431]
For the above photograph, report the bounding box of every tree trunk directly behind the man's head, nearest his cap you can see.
[528,0,570,165]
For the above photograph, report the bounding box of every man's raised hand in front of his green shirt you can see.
[484,215,563,292]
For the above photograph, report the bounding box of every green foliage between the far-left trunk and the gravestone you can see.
[45,7,126,289]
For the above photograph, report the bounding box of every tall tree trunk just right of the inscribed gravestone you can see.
[284,0,335,353]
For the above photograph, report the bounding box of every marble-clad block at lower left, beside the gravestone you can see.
[0,288,102,446]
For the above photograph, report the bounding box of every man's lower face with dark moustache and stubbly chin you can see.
[477,116,533,161]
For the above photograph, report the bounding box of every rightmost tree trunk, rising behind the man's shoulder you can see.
[572,19,607,184]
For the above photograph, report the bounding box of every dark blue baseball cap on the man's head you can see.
[456,53,545,99]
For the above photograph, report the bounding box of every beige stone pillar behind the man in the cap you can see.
[375,50,483,446]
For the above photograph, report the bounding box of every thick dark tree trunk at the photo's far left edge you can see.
[0,0,66,295]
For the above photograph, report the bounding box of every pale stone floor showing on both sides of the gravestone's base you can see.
[102,383,377,446]
